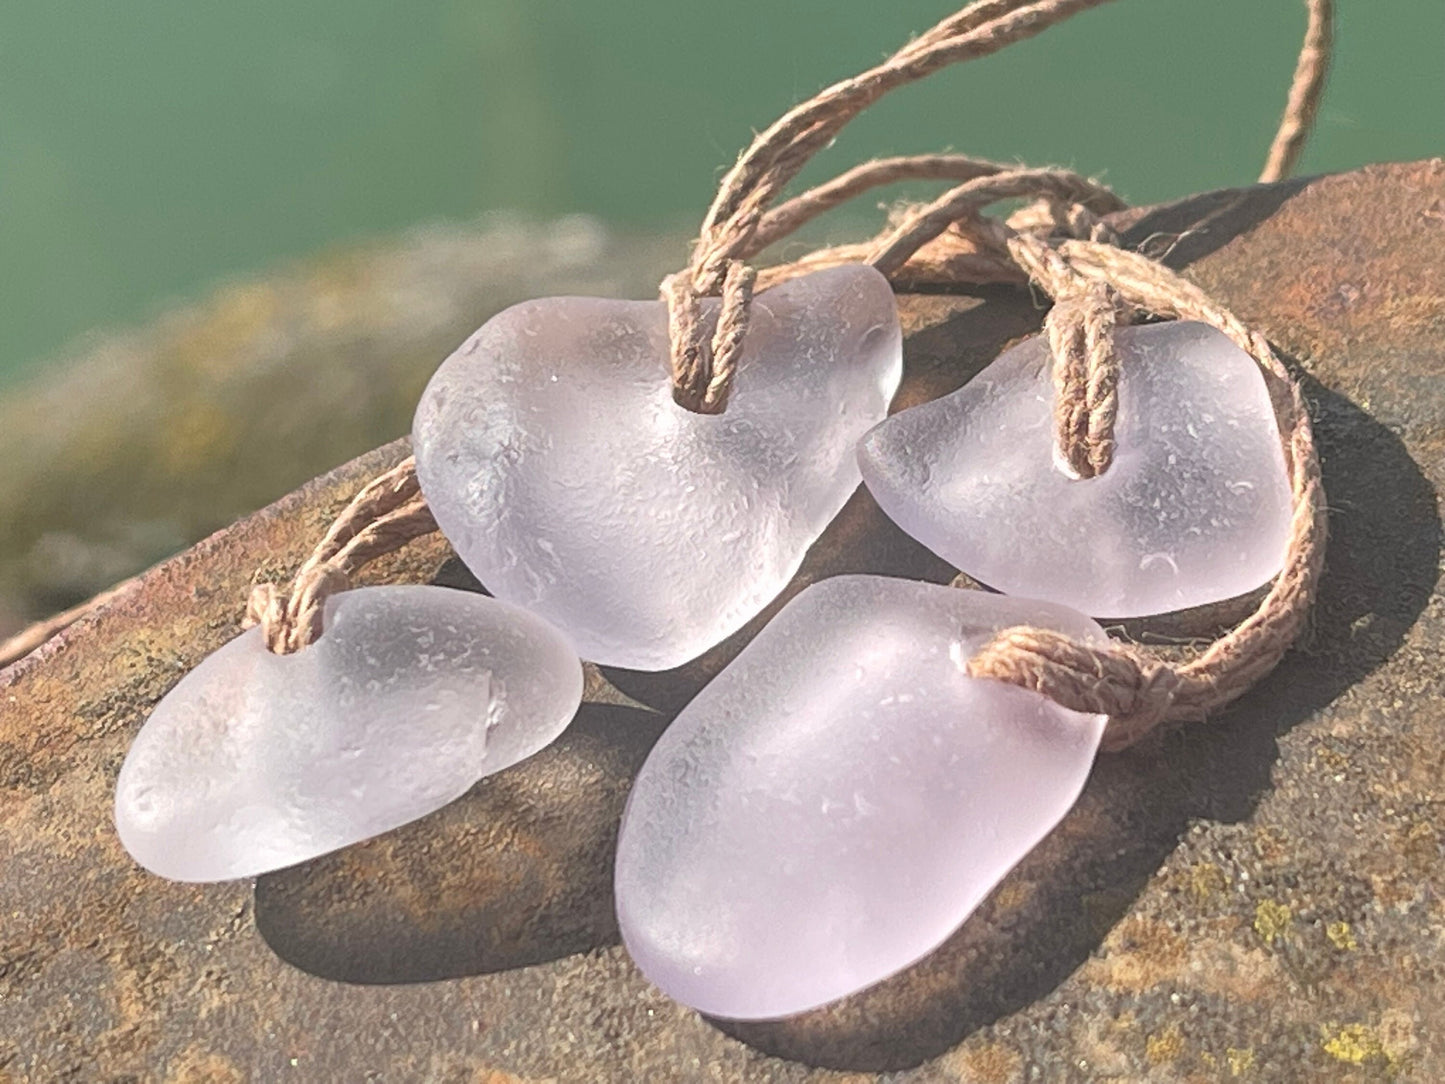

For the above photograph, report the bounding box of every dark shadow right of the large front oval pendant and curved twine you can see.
[714,379,1441,1071]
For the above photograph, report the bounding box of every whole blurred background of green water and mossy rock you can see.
[0,0,1445,636]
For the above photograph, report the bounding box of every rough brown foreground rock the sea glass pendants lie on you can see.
[0,160,1445,1083]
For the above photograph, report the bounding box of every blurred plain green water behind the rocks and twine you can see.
[0,0,1445,379]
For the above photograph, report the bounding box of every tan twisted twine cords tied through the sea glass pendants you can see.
[56,0,1332,750]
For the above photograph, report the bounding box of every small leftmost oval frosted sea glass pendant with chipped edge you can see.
[116,587,582,882]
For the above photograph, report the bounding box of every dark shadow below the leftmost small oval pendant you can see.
[256,704,665,983]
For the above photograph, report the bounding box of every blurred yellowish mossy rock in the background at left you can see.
[0,217,686,639]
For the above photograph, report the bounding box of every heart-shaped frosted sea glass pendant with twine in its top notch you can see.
[412,264,902,671]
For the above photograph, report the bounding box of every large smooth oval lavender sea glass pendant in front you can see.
[617,575,1105,1019]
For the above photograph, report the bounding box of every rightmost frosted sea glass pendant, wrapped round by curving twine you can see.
[858,322,1290,617]
